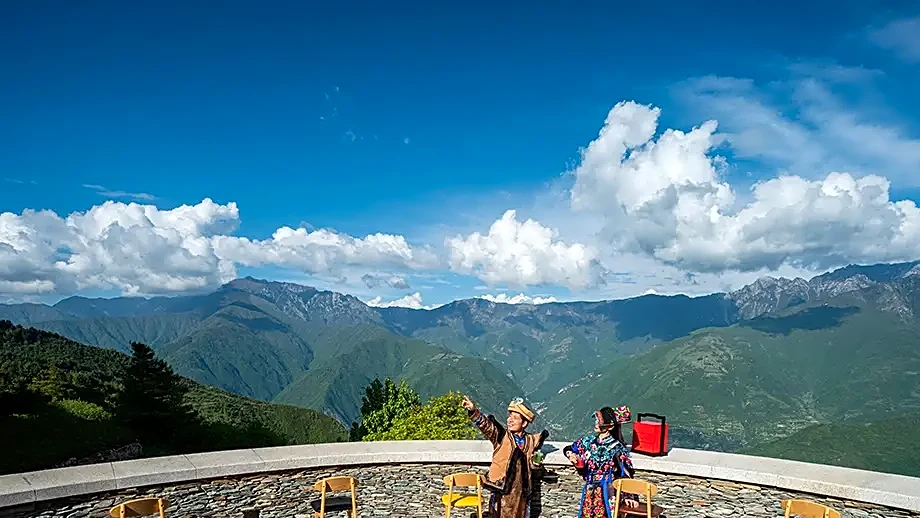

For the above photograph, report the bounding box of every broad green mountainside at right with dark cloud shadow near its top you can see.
[548,292,920,449]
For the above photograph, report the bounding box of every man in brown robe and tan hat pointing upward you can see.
[463,396,549,518]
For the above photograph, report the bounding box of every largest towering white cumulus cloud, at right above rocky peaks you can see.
[571,102,920,272]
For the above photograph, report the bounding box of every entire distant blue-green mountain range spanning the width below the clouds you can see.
[0,262,920,458]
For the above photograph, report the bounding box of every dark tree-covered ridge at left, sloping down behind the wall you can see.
[0,320,347,473]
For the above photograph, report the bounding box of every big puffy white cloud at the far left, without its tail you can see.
[0,199,238,294]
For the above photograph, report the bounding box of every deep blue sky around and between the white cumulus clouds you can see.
[0,2,920,304]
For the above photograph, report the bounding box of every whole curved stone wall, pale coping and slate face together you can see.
[0,441,920,518]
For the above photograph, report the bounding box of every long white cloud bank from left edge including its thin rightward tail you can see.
[0,199,434,295]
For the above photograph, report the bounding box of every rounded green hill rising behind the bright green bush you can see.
[275,335,521,424]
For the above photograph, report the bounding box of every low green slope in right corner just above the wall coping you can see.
[739,415,920,477]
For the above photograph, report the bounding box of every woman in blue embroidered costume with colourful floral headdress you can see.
[562,406,639,518]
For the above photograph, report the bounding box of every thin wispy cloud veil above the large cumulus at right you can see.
[674,73,920,186]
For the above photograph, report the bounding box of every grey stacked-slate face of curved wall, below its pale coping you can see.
[0,464,920,518]
